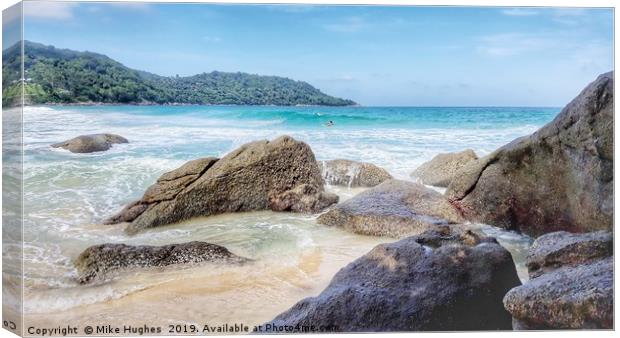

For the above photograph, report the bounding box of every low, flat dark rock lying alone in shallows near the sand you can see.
[75,242,248,284]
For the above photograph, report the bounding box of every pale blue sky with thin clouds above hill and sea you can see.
[18,2,613,106]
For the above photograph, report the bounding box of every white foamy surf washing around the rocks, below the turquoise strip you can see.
[24,107,539,311]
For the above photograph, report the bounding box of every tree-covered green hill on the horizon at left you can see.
[2,41,355,106]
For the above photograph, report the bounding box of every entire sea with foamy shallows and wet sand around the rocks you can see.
[8,105,560,334]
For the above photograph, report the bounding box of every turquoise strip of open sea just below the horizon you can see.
[64,106,559,129]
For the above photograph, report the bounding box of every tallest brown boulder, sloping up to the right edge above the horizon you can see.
[446,72,614,235]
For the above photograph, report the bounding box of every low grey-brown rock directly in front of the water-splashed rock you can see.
[318,179,462,238]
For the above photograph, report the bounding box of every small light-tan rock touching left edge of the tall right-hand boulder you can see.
[411,149,478,188]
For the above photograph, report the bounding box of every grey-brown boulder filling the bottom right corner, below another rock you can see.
[504,257,614,330]
